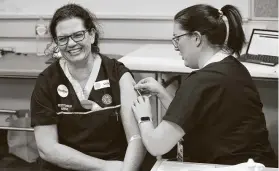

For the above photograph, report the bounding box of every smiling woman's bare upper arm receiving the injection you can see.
[119,72,140,141]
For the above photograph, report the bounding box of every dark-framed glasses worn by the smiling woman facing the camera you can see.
[55,30,88,46]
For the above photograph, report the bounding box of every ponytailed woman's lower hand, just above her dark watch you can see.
[132,96,152,121]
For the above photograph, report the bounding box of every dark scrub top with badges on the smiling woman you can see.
[31,56,132,170]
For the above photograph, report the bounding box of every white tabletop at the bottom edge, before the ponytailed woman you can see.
[151,160,278,171]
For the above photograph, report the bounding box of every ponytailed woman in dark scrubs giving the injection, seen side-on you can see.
[132,4,278,167]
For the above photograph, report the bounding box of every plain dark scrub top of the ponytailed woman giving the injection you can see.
[163,56,277,167]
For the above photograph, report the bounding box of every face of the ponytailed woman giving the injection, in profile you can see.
[173,22,200,69]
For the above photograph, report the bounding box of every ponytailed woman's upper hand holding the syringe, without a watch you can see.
[134,77,165,96]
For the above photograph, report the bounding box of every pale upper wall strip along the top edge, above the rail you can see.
[0,0,250,19]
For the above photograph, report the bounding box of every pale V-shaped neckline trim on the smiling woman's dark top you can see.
[59,55,102,101]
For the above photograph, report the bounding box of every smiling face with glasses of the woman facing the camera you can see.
[56,18,95,63]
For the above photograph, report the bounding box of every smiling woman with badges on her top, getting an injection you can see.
[31,4,145,171]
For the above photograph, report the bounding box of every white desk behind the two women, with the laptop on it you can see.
[119,44,278,123]
